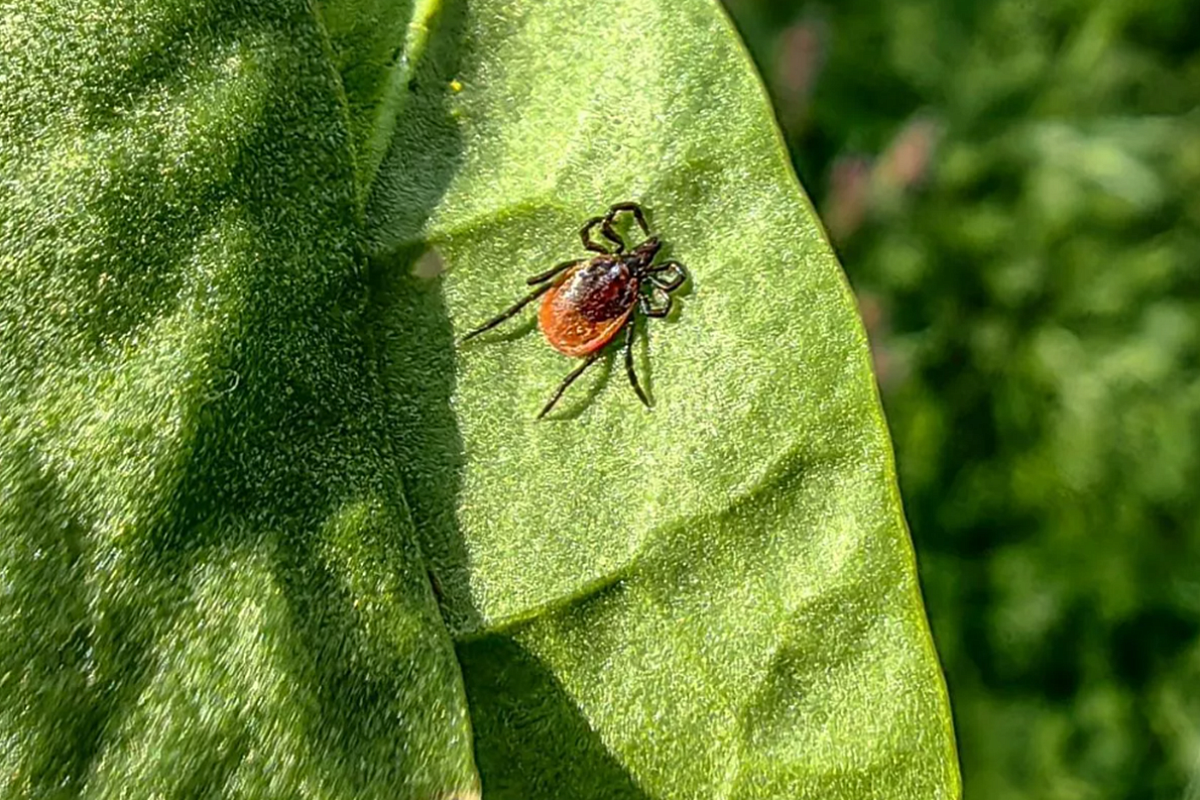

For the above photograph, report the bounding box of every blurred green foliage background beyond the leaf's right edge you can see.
[726,0,1200,800]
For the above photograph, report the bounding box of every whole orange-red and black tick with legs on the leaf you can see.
[462,203,688,420]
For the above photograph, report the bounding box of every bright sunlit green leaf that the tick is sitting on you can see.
[367,0,959,800]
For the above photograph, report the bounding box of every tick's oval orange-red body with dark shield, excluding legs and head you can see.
[538,255,638,359]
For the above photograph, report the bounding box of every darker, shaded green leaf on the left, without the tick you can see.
[0,0,476,798]
